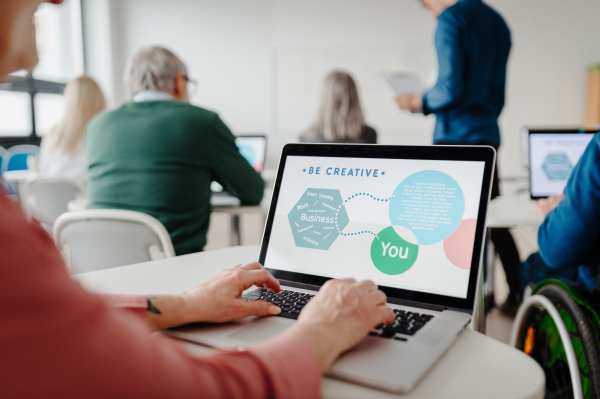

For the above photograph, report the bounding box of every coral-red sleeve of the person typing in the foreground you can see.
[0,196,320,398]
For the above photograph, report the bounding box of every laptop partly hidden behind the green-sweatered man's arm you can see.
[210,134,267,206]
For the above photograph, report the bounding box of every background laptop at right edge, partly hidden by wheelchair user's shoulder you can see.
[527,129,598,200]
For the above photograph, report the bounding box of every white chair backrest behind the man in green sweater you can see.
[54,209,175,273]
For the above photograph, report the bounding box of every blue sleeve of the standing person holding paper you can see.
[423,10,465,115]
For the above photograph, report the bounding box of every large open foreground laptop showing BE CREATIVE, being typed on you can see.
[169,144,496,393]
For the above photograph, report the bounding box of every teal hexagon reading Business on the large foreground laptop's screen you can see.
[288,188,350,250]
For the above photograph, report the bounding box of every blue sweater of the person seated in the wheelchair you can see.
[538,134,600,291]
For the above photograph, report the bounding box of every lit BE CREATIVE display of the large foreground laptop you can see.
[261,155,489,299]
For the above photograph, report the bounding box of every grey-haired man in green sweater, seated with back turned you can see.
[86,47,264,255]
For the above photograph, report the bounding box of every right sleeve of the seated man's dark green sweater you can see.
[207,114,265,205]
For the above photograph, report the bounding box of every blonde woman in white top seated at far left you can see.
[39,75,106,183]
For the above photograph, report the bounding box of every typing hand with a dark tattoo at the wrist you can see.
[146,262,281,329]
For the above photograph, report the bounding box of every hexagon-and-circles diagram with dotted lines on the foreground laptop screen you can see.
[287,170,476,275]
